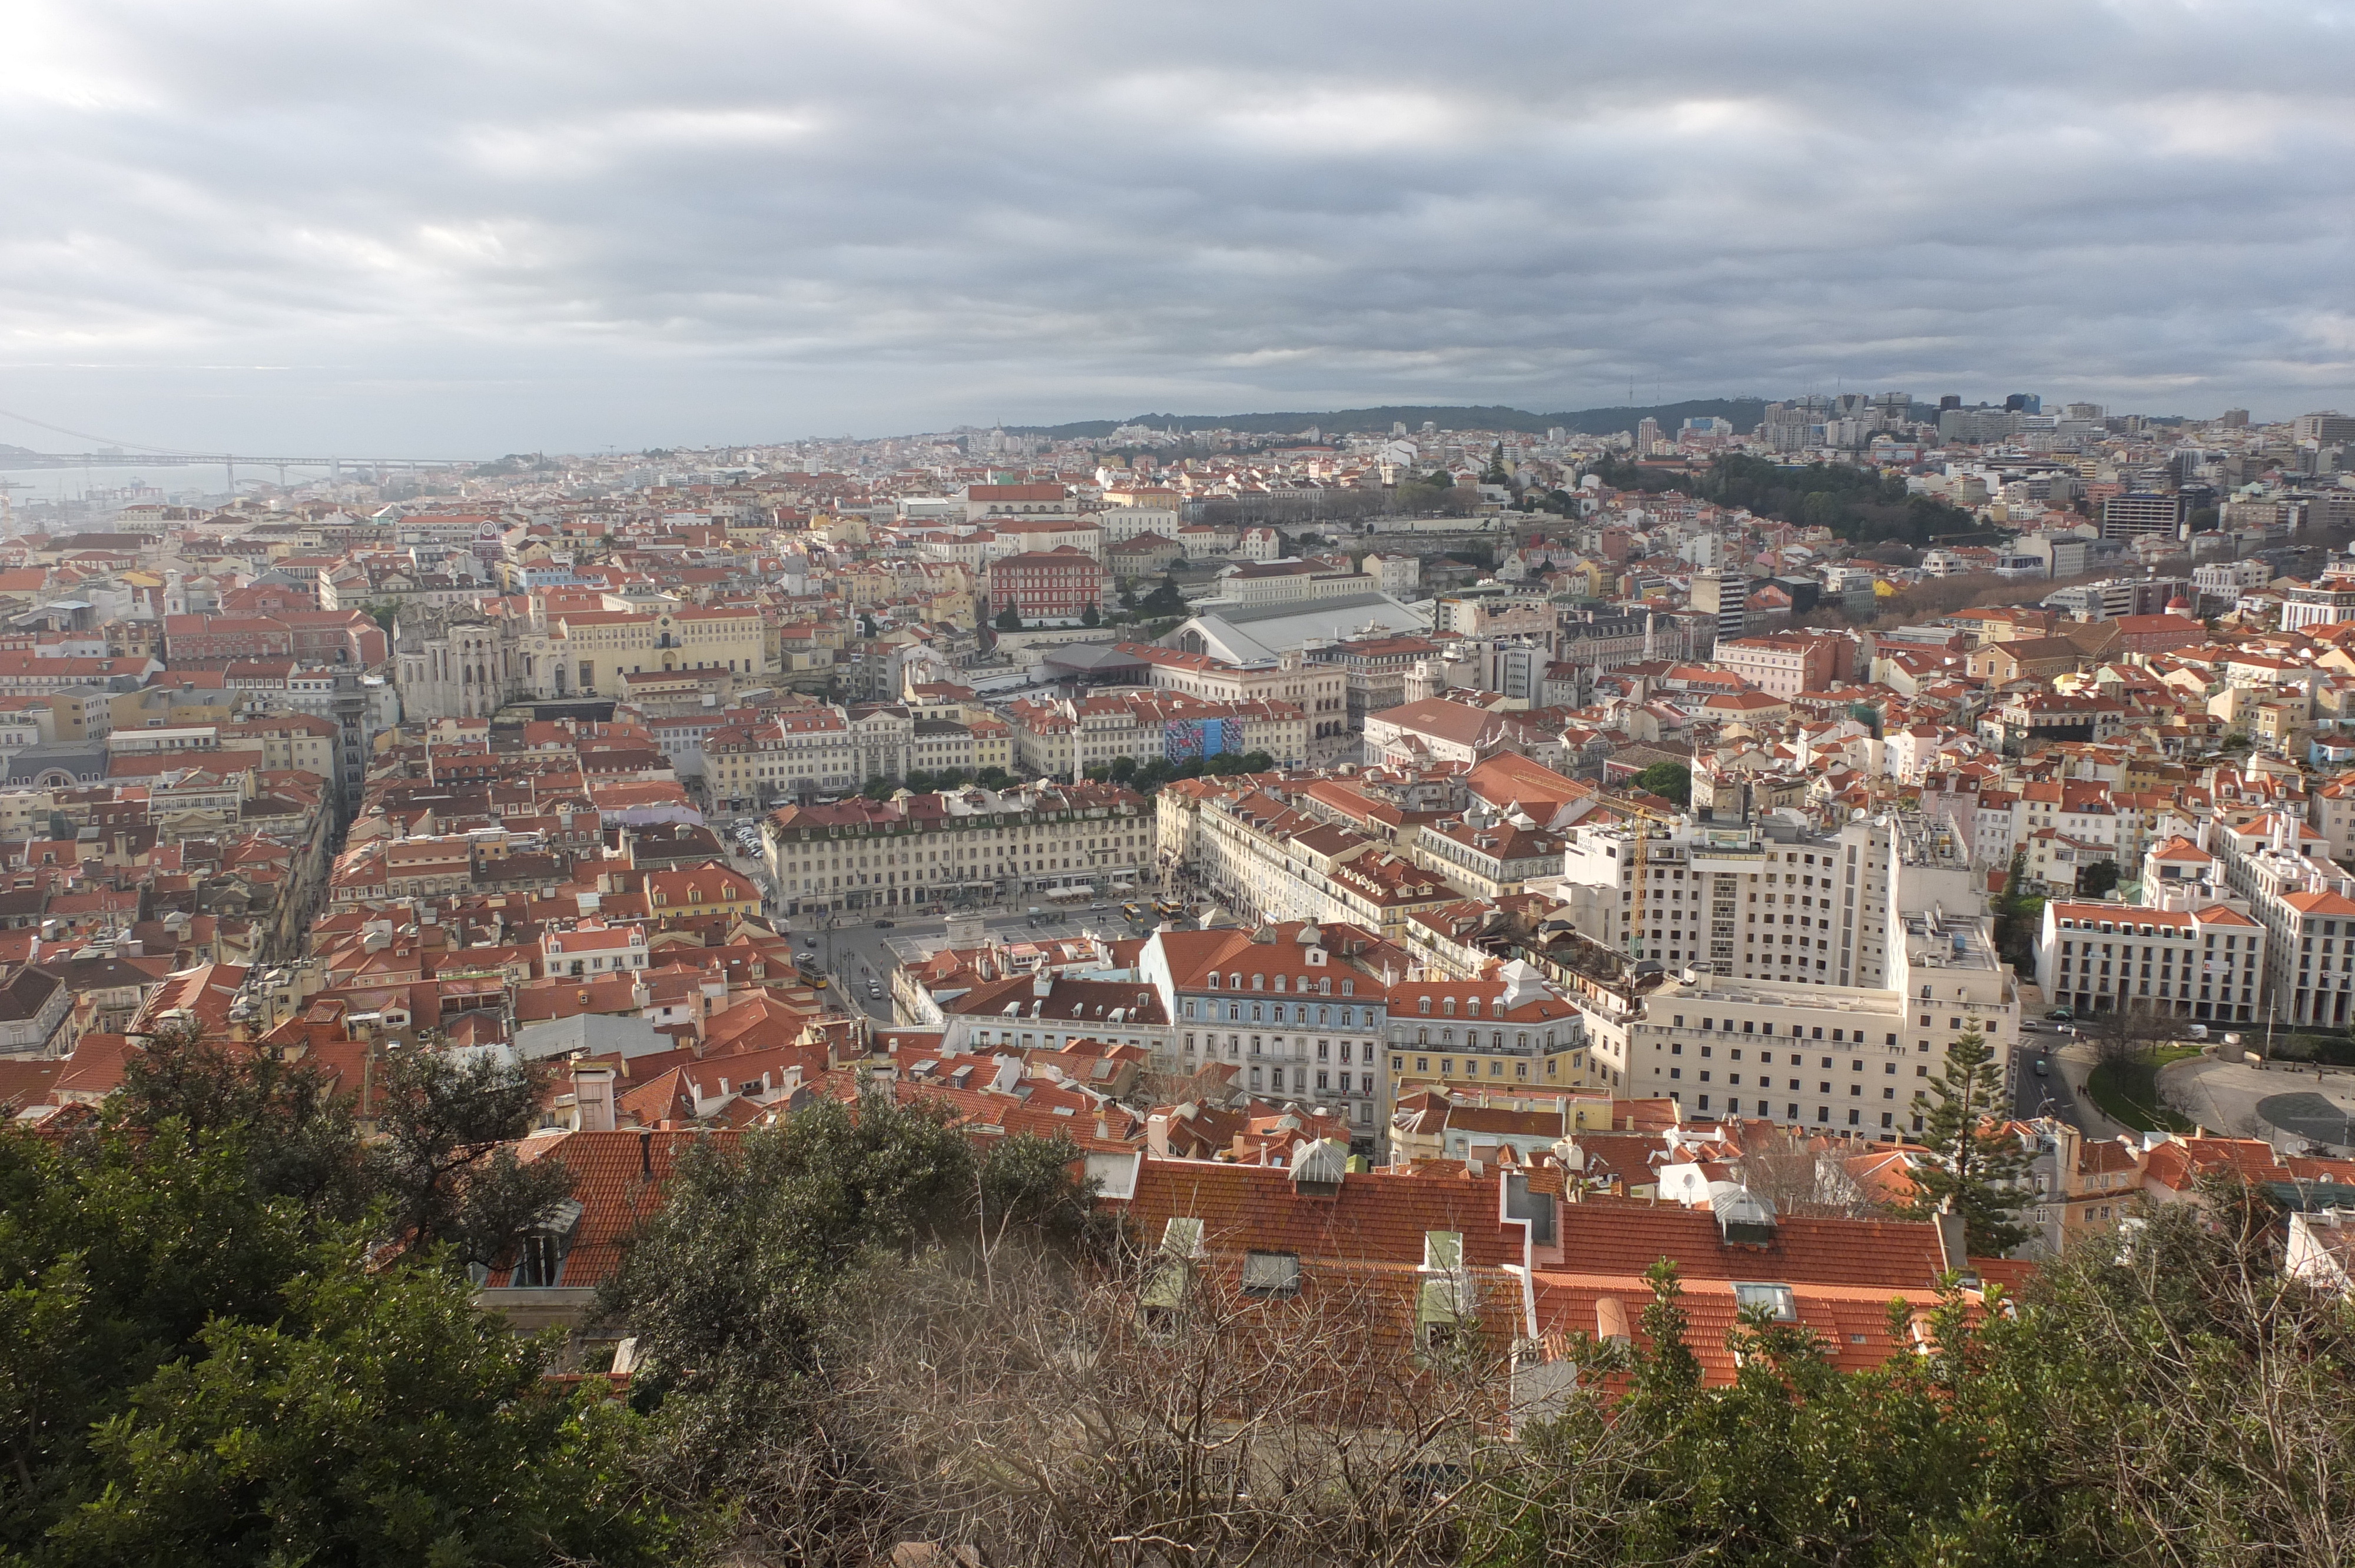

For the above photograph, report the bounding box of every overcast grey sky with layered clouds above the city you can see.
[0,0,2355,457]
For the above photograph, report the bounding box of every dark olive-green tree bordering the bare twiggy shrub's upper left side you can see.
[601,1095,1095,1561]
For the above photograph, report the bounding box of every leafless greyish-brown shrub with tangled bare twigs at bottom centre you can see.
[711,1245,1510,1568]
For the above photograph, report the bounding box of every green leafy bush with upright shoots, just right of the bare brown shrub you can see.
[1460,1260,2096,1568]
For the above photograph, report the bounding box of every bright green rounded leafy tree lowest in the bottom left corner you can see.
[35,1243,681,1568]
